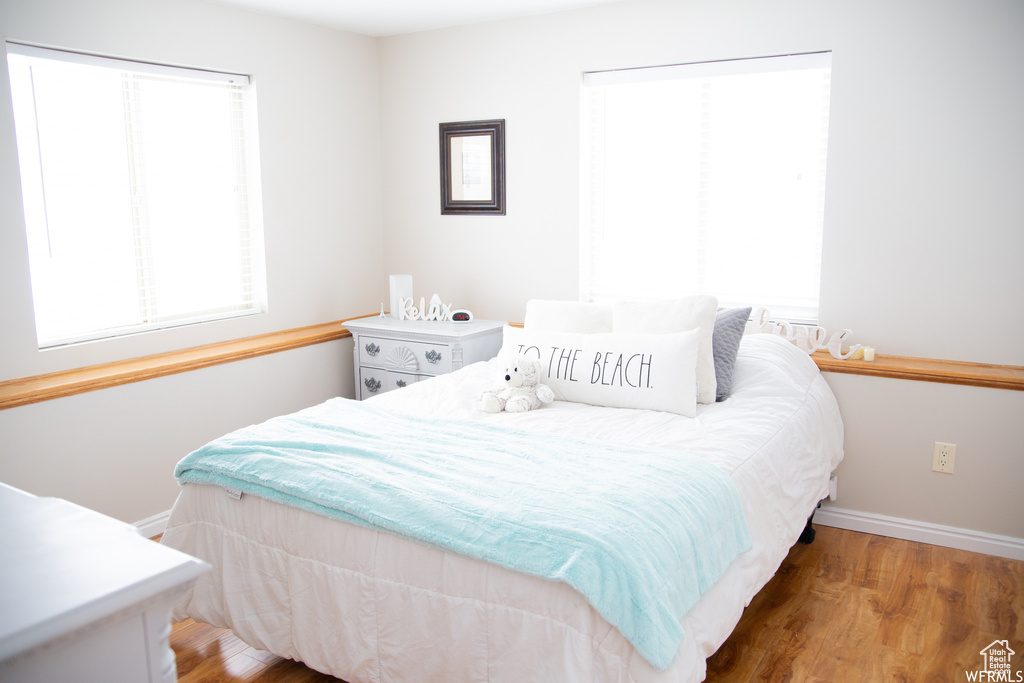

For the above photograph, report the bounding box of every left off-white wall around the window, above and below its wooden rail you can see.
[0,0,384,521]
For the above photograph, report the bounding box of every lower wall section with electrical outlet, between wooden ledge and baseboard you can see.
[825,374,1024,539]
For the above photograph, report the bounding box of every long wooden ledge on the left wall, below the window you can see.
[0,321,352,411]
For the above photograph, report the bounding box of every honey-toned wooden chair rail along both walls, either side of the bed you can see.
[0,316,1024,410]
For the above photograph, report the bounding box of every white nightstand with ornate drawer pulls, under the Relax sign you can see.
[345,316,505,400]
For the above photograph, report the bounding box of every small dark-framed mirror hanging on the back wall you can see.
[438,119,505,216]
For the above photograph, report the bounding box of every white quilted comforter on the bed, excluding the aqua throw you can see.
[163,305,843,683]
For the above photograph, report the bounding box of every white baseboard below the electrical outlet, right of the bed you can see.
[814,506,1024,560]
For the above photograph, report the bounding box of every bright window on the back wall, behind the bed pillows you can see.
[580,53,830,322]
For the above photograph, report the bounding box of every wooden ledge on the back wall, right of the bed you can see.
[811,351,1024,391]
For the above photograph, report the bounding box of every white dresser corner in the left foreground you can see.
[0,483,209,683]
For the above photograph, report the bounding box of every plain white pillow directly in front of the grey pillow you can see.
[611,295,718,403]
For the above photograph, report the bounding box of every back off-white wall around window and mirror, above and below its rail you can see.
[379,0,1024,538]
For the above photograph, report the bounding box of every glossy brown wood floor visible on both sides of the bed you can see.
[171,526,1024,683]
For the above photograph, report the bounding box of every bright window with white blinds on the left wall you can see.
[7,43,266,348]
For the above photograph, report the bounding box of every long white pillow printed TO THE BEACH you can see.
[501,326,699,418]
